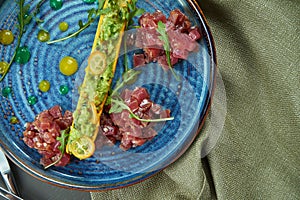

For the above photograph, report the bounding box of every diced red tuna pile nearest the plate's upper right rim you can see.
[134,9,201,70]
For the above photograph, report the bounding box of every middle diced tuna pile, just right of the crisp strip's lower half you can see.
[97,87,170,150]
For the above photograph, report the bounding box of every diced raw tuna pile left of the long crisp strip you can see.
[23,106,73,166]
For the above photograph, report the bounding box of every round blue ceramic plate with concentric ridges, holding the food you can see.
[0,0,216,191]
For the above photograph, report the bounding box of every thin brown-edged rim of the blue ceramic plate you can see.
[0,0,217,192]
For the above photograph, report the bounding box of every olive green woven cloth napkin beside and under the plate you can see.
[91,0,300,200]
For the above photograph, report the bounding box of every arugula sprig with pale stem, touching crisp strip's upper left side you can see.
[47,0,111,44]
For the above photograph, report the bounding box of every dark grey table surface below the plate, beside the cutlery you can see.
[0,159,91,200]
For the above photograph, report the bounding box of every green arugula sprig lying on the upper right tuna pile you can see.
[157,21,180,81]
